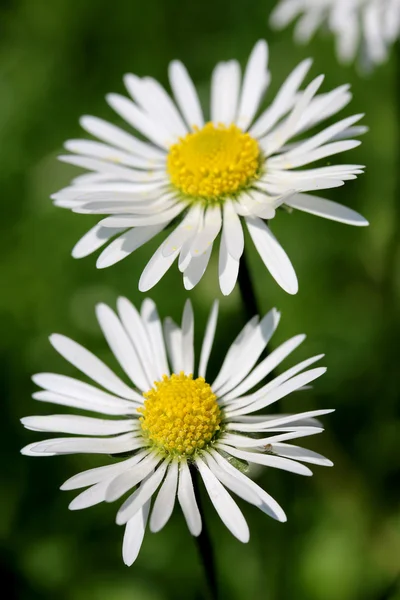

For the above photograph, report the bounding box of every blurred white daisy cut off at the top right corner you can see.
[271,0,400,68]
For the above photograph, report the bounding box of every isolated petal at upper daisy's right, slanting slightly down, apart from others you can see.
[287,194,369,227]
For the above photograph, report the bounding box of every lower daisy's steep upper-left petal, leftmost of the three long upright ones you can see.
[96,304,152,391]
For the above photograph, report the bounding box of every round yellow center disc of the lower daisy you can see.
[137,372,221,455]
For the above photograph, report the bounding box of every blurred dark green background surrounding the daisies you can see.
[0,0,400,600]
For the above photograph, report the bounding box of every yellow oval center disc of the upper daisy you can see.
[167,123,261,200]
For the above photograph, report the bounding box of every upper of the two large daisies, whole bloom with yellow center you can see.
[53,41,367,295]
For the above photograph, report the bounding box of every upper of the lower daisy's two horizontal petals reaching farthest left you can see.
[21,415,136,435]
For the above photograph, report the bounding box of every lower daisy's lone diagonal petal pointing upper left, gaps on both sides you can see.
[50,333,137,400]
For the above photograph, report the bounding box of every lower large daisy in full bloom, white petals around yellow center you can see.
[22,298,332,565]
